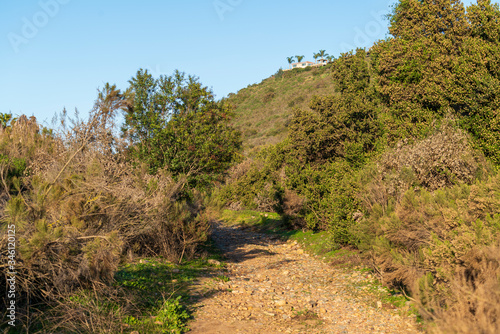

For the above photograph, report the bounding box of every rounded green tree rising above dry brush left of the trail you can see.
[123,69,241,187]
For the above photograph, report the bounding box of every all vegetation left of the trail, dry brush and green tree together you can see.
[0,70,240,333]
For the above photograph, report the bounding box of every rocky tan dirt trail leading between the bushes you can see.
[190,224,419,334]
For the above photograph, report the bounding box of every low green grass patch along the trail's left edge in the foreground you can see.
[99,258,223,333]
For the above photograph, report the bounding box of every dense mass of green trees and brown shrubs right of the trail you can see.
[218,0,500,333]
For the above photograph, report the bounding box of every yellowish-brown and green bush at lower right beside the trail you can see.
[359,175,500,328]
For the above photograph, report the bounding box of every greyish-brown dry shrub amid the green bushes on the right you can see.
[360,120,491,214]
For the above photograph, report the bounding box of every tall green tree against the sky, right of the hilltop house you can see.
[373,0,469,115]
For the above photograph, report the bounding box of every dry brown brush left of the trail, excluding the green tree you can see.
[0,100,209,333]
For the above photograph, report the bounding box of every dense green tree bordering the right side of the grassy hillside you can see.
[288,49,380,163]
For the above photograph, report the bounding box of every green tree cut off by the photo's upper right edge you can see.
[453,0,500,164]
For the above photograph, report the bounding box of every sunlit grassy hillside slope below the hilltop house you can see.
[228,64,334,153]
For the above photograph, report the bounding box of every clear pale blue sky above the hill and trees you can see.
[0,0,471,125]
